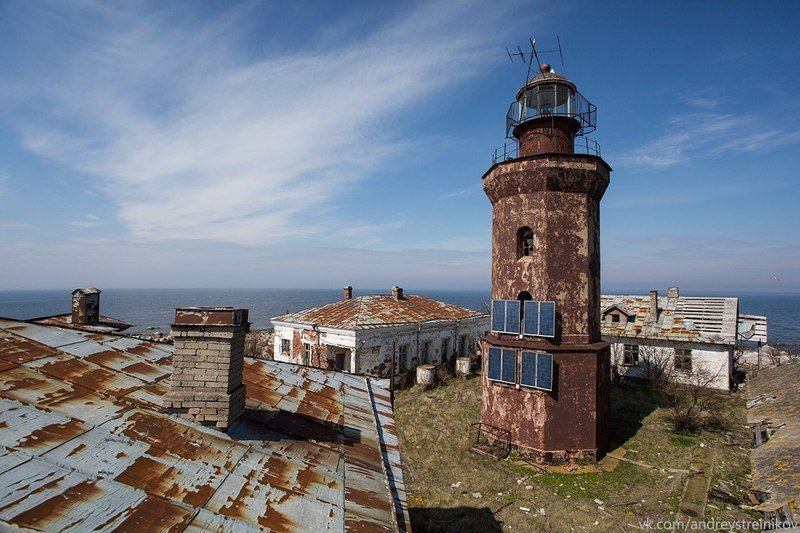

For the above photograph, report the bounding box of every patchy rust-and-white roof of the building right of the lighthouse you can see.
[601,294,739,345]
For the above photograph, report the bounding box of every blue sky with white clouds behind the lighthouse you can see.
[0,1,800,293]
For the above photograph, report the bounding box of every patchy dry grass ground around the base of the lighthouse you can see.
[395,379,750,532]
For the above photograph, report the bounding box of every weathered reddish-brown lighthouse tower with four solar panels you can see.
[481,63,611,462]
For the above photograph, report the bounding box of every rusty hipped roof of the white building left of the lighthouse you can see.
[272,294,487,330]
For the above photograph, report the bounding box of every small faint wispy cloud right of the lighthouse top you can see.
[615,112,800,167]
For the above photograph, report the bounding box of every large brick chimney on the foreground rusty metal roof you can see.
[164,307,250,431]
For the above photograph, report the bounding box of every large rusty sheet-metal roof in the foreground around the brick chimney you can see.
[0,319,409,531]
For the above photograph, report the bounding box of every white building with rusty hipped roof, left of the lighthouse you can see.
[272,286,489,378]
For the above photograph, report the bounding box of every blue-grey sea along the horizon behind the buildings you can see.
[0,289,800,353]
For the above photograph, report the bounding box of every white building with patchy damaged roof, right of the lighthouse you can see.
[601,287,767,390]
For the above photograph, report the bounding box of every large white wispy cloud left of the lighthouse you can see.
[7,2,502,244]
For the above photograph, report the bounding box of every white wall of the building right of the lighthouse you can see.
[609,338,733,391]
